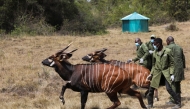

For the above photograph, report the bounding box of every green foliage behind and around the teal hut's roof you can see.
[98,0,190,26]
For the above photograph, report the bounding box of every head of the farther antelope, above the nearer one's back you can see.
[82,48,107,62]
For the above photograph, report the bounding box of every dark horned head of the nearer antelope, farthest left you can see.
[42,44,77,67]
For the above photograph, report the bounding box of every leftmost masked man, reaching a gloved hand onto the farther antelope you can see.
[127,38,151,70]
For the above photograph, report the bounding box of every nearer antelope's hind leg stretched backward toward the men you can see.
[127,88,146,108]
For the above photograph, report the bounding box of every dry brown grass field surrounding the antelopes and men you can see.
[0,22,190,109]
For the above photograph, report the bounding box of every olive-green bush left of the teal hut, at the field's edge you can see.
[59,2,105,35]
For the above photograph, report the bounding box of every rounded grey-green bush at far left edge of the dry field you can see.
[11,15,55,36]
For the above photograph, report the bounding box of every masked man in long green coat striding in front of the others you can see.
[147,38,180,109]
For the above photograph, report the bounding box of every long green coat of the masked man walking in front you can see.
[150,47,174,89]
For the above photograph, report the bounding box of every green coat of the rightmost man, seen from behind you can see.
[167,42,185,82]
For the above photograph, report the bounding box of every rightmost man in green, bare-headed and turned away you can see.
[166,36,185,106]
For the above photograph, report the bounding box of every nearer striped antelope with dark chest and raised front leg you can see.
[42,46,146,109]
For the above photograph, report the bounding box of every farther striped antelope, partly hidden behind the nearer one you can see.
[82,49,158,97]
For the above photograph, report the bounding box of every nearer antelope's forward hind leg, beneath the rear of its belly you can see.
[106,93,121,109]
